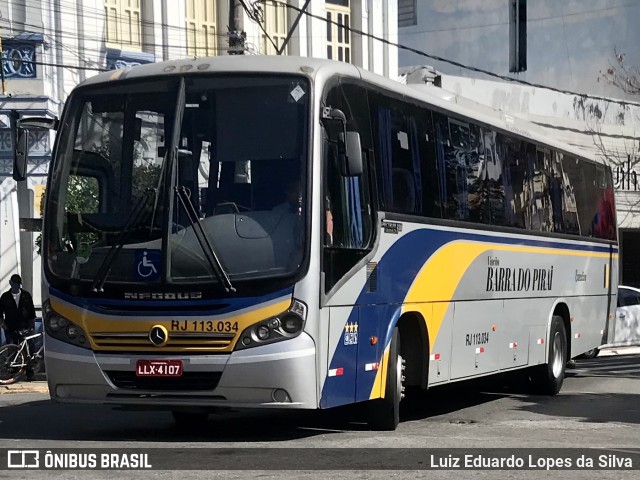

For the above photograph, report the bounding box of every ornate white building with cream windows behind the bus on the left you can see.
[0,0,398,299]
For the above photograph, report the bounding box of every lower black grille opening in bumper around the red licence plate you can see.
[105,370,222,391]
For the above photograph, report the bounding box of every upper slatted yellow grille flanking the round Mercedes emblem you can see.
[91,332,234,351]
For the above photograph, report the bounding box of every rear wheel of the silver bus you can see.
[532,315,568,396]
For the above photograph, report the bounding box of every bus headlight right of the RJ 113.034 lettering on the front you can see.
[235,300,307,350]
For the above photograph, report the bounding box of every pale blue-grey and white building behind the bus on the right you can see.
[398,0,640,286]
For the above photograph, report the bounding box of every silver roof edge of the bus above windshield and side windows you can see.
[80,55,602,163]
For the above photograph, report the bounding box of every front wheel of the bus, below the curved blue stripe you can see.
[368,327,404,430]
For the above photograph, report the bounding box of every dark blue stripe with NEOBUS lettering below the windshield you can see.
[49,287,293,317]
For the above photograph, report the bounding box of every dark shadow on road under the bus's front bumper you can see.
[0,400,368,442]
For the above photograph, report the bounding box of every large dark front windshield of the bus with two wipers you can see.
[45,75,310,288]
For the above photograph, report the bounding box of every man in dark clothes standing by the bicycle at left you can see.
[0,274,36,379]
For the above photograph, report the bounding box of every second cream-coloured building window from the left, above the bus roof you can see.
[185,0,218,57]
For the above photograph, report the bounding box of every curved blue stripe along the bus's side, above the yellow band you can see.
[320,228,618,408]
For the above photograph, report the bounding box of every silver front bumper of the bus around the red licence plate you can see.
[45,333,318,408]
